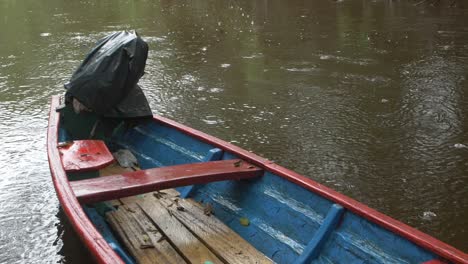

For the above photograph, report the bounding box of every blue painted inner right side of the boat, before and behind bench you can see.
[59,118,437,263]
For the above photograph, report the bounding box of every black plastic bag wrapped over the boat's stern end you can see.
[65,31,152,118]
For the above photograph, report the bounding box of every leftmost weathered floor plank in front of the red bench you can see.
[107,204,186,264]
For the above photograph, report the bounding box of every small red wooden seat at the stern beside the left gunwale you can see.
[59,140,114,172]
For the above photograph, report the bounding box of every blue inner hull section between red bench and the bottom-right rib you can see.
[191,170,333,263]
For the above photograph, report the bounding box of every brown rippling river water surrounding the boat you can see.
[0,0,468,263]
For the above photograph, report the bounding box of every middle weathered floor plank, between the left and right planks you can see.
[138,195,223,263]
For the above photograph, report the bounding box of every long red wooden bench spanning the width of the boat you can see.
[70,160,263,203]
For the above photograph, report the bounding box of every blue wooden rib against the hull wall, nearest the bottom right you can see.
[295,204,344,264]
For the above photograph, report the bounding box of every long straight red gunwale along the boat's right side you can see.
[153,116,468,264]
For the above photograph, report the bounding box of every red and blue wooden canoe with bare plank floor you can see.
[47,96,468,264]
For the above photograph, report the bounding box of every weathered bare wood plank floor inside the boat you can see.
[100,164,272,264]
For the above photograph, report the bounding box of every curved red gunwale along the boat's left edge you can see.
[47,96,123,264]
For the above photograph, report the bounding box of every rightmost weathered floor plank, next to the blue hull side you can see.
[159,196,273,264]
